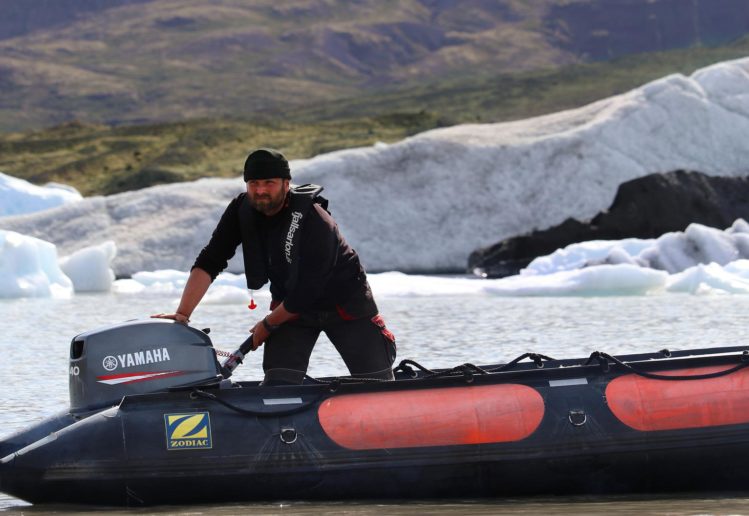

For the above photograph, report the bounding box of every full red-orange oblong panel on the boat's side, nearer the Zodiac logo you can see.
[318,384,544,450]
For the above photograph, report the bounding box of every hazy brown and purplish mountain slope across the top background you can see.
[0,0,749,131]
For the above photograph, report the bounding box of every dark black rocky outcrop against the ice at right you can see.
[468,170,749,278]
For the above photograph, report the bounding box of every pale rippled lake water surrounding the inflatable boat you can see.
[0,288,749,515]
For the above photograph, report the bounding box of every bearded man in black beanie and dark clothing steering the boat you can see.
[154,149,395,385]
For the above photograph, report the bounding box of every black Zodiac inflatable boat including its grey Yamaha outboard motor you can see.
[0,320,749,506]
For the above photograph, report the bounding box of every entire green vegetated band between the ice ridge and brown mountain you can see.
[0,38,749,195]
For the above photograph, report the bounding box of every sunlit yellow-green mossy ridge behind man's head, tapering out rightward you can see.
[0,112,438,195]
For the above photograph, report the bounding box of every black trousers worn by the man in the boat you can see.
[263,311,395,385]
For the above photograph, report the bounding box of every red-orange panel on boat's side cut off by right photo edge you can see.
[606,366,749,432]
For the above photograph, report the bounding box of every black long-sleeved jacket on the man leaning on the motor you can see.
[193,185,377,318]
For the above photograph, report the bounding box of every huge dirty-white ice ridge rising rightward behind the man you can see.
[0,58,749,276]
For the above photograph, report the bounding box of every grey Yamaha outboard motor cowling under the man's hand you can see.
[69,319,221,412]
